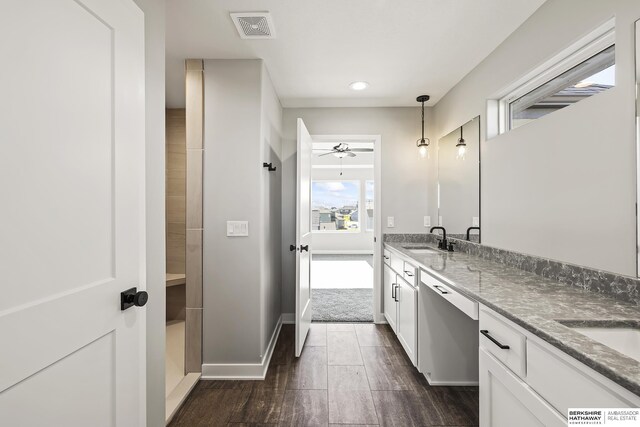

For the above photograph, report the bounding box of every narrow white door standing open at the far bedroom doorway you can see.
[296,119,313,357]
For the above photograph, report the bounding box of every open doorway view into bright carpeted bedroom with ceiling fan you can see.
[311,136,378,322]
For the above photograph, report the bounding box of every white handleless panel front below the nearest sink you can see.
[527,340,637,414]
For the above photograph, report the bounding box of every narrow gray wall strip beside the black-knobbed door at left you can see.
[135,0,166,426]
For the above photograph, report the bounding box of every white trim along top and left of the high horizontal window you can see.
[487,17,616,137]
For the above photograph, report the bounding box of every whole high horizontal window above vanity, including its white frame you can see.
[496,19,616,138]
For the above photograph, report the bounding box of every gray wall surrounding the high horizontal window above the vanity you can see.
[430,0,640,275]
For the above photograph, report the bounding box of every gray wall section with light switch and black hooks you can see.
[203,60,281,364]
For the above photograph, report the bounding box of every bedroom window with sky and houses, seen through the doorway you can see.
[311,181,360,233]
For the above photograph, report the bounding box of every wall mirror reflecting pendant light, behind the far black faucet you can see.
[438,116,481,242]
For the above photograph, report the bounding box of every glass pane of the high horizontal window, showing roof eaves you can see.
[509,46,616,129]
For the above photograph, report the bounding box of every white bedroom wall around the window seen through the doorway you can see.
[311,167,374,254]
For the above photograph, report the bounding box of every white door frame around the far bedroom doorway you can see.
[311,134,387,323]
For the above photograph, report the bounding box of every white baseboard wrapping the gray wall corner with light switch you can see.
[200,315,283,380]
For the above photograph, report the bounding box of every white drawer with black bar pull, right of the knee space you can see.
[480,310,527,378]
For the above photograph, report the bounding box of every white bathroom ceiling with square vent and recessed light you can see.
[166,0,545,108]
